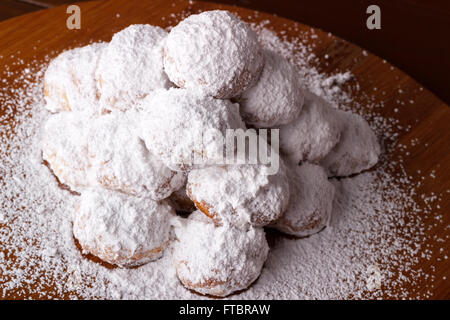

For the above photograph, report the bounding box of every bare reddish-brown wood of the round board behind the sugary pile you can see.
[0,0,450,299]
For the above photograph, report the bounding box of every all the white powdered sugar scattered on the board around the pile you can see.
[0,18,448,299]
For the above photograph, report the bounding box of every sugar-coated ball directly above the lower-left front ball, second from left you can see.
[87,112,186,200]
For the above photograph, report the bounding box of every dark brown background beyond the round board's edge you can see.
[0,0,450,104]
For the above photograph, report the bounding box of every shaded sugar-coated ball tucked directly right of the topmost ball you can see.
[239,49,304,128]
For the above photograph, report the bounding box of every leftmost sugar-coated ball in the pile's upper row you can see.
[44,43,106,114]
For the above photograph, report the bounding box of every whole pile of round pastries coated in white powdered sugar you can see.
[42,11,380,297]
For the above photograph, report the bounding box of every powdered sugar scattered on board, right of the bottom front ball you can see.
[244,170,424,299]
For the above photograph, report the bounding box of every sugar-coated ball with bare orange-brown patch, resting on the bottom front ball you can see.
[186,164,289,228]
